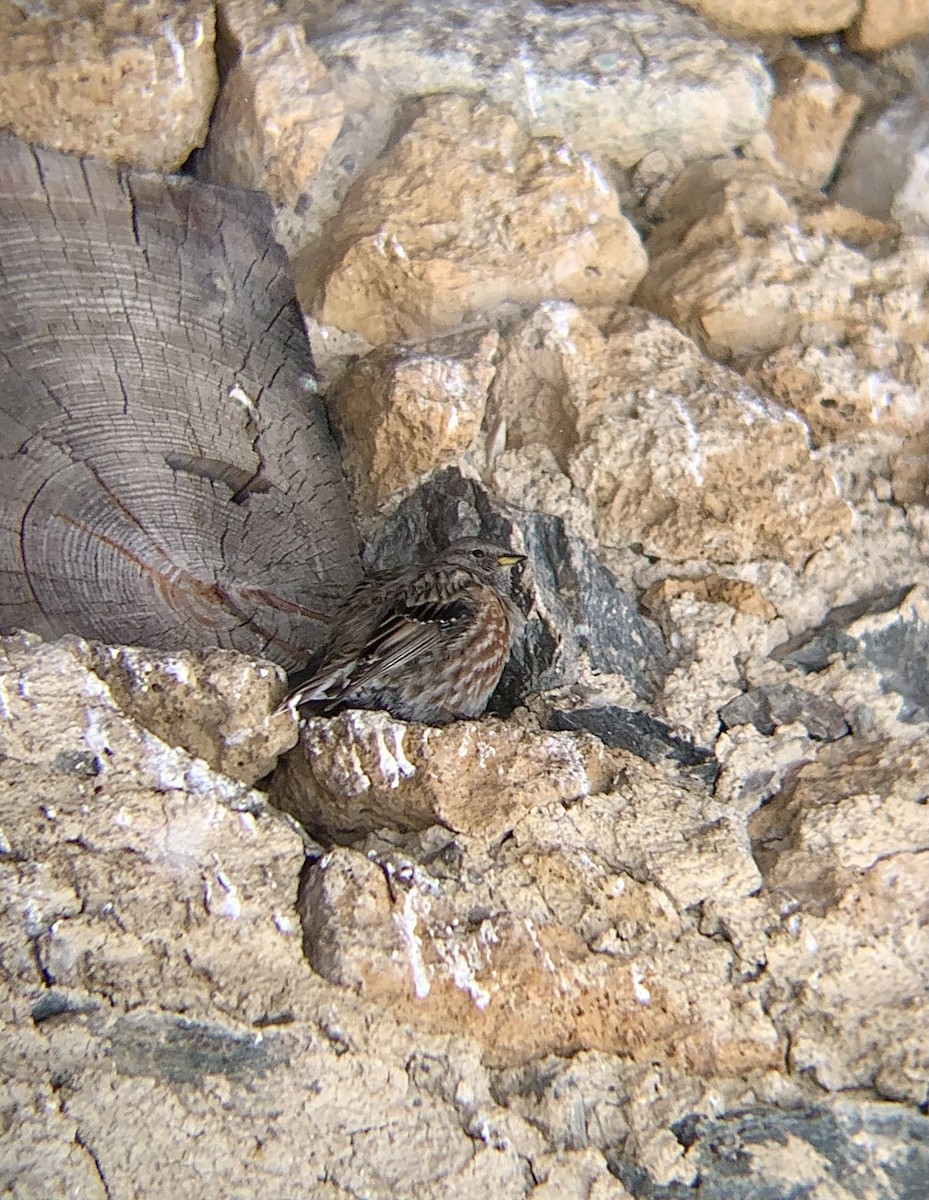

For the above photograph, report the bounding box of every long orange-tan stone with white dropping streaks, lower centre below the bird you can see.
[301,825,779,1074]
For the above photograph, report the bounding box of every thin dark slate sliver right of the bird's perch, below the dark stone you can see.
[549,704,719,787]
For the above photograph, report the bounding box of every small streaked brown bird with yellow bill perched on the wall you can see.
[281,538,526,725]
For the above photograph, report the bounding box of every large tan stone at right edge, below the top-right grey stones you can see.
[636,160,929,373]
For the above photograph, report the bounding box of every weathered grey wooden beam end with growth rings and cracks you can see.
[0,138,360,668]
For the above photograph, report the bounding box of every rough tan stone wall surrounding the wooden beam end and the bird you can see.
[7,0,929,1200]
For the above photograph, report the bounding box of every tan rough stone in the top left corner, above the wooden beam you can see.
[0,0,217,172]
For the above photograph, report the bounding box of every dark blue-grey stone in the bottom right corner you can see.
[607,1100,929,1200]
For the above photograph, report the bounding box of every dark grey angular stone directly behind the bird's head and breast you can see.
[365,468,669,714]
